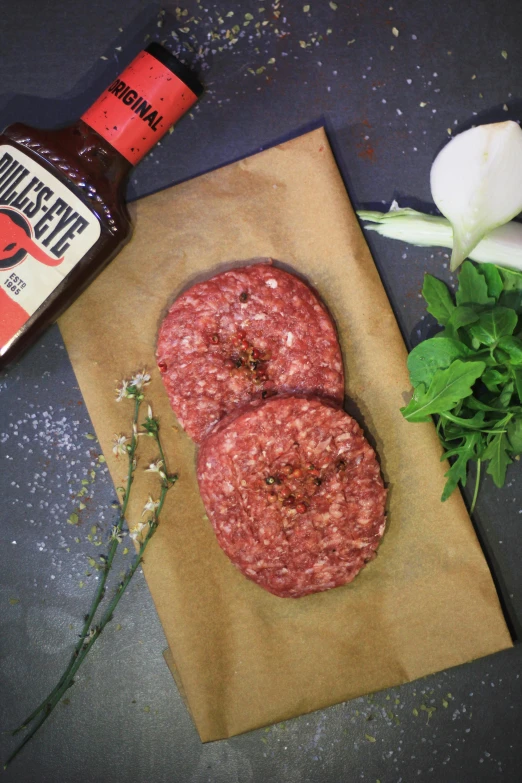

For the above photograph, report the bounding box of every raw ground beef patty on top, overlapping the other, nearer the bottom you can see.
[198,396,386,598]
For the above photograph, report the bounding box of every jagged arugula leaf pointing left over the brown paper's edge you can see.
[401,359,486,421]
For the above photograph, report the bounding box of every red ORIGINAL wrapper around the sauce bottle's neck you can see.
[82,52,197,165]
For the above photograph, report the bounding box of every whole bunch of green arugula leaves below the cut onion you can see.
[401,261,522,510]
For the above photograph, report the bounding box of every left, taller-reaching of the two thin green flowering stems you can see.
[13,395,142,735]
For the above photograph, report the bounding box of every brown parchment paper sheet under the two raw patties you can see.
[60,129,511,741]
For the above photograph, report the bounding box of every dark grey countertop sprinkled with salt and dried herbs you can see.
[0,0,522,783]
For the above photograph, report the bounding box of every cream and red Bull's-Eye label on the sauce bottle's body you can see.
[0,144,101,356]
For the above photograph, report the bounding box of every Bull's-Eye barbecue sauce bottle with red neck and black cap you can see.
[0,43,203,369]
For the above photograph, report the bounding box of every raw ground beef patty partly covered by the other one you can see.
[156,263,344,443]
